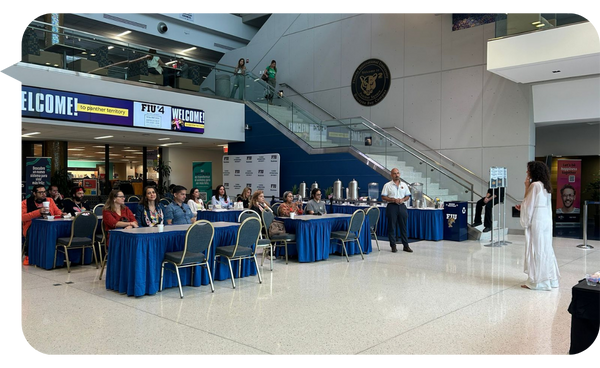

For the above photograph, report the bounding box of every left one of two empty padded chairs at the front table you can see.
[158,220,215,298]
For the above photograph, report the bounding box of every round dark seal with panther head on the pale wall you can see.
[350,59,391,106]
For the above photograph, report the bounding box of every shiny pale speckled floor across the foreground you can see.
[19,235,600,357]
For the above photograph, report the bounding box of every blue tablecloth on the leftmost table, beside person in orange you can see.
[27,218,94,270]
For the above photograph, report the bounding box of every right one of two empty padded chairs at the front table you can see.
[215,217,262,289]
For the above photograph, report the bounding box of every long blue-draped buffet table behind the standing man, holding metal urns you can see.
[327,204,444,241]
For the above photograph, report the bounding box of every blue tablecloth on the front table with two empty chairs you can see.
[106,223,256,296]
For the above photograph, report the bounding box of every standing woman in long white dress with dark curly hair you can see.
[516,161,560,290]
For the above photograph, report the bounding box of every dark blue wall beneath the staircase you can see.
[229,106,390,200]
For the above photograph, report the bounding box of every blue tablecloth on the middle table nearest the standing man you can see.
[277,214,372,262]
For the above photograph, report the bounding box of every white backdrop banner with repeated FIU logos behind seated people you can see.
[223,153,280,200]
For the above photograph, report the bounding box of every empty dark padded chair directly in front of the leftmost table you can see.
[53,211,98,273]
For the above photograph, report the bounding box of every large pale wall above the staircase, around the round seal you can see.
[221,10,535,227]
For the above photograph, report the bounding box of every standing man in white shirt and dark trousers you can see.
[381,168,412,253]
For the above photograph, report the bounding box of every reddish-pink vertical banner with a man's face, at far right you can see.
[556,159,581,223]
